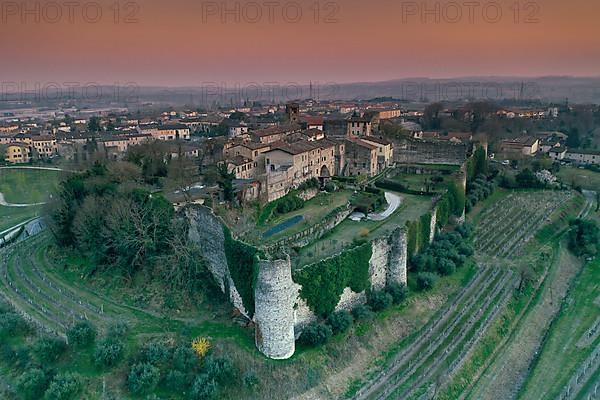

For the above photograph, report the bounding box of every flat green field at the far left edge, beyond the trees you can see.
[0,169,62,204]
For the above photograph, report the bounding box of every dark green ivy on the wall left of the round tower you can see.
[223,226,258,318]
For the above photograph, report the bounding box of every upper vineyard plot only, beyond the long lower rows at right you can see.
[474,191,572,258]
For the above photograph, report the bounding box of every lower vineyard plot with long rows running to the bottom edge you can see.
[355,267,515,399]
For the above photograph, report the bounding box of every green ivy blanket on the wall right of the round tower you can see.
[293,243,373,317]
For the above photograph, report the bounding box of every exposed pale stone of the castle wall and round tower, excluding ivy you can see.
[183,206,407,359]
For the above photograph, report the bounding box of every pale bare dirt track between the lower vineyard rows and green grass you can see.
[469,246,580,400]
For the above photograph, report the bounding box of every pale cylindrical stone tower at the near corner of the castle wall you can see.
[254,257,298,360]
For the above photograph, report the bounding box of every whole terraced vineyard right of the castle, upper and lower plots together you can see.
[354,192,572,399]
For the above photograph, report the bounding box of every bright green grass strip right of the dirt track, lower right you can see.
[520,259,600,399]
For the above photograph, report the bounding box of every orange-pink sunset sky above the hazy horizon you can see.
[0,0,600,86]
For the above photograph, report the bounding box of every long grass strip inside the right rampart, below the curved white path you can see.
[294,194,431,266]
